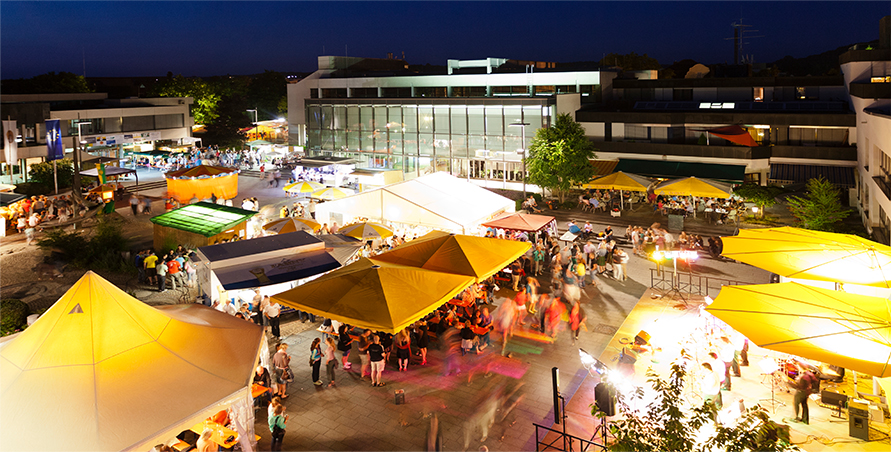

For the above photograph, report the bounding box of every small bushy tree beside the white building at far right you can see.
[788,176,851,232]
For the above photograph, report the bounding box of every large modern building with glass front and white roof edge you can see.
[288,56,616,189]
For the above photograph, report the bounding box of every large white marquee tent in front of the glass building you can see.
[316,172,516,234]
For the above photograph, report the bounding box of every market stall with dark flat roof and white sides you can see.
[193,231,362,306]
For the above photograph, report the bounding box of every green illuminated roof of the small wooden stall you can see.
[151,202,257,237]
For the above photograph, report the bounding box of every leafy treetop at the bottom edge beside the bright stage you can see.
[608,362,798,452]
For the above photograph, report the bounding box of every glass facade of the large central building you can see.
[306,98,554,182]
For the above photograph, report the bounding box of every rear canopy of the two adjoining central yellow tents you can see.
[372,231,532,281]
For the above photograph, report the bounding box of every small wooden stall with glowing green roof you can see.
[151,202,257,251]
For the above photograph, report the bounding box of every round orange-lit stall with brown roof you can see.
[164,165,240,203]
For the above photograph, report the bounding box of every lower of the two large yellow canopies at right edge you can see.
[706,282,891,377]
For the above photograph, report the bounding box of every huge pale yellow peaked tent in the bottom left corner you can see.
[0,272,263,451]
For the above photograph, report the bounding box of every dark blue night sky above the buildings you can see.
[0,0,891,79]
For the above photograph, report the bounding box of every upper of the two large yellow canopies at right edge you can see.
[722,227,891,288]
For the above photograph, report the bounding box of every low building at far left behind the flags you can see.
[0,93,195,179]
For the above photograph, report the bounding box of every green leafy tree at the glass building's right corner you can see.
[526,114,597,202]
